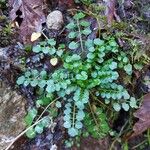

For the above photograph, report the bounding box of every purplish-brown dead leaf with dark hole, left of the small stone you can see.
[9,0,45,43]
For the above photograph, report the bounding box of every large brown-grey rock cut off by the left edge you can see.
[0,80,26,150]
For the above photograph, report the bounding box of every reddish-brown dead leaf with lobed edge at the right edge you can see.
[132,93,150,136]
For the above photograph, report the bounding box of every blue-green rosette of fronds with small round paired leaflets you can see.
[17,13,137,137]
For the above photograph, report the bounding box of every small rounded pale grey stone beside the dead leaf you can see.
[46,10,64,30]
